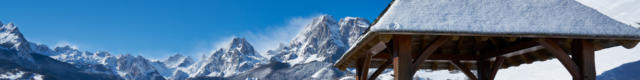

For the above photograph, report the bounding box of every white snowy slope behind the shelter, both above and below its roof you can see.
[496,0,640,80]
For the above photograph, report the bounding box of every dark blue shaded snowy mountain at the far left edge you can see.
[0,23,121,80]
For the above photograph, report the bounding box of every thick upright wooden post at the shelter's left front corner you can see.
[392,35,414,80]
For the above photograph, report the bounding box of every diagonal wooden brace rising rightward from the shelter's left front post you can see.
[412,36,451,70]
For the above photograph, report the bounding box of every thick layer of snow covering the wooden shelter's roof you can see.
[370,0,640,40]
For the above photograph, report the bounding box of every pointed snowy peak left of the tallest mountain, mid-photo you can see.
[190,38,266,77]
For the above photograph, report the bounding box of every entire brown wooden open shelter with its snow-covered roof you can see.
[334,0,640,80]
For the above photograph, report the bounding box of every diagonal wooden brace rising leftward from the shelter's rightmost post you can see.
[539,39,582,80]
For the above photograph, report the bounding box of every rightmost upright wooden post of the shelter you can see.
[572,39,596,80]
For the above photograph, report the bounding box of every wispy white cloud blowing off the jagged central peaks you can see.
[192,14,320,58]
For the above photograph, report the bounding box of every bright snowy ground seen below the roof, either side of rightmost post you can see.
[496,45,640,80]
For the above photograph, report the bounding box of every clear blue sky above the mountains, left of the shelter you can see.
[0,0,391,59]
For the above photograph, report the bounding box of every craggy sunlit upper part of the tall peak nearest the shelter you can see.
[268,15,369,66]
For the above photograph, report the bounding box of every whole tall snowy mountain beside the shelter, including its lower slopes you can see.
[192,15,369,80]
